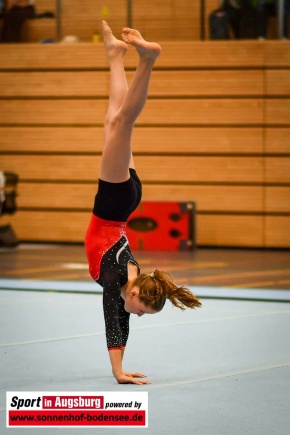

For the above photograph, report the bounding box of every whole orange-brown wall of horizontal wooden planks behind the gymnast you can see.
[0,41,290,247]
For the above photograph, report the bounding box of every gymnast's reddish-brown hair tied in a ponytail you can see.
[134,269,201,311]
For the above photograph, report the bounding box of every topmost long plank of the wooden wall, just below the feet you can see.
[0,41,266,71]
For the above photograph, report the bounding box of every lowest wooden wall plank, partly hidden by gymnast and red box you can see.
[2,210,264,247]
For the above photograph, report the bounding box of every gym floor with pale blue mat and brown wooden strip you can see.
[0,244,290,435]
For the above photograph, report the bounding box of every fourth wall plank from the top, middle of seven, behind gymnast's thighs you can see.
[0,126,264,155]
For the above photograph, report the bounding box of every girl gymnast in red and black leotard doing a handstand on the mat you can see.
[85,21,201,384]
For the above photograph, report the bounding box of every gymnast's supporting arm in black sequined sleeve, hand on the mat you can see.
[101,271,150,384]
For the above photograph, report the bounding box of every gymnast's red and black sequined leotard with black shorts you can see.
[85,169,142,350]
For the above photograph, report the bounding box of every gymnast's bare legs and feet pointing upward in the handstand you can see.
[100,22,161,183]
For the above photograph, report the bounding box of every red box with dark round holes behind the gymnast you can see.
[127,201,195,251]
